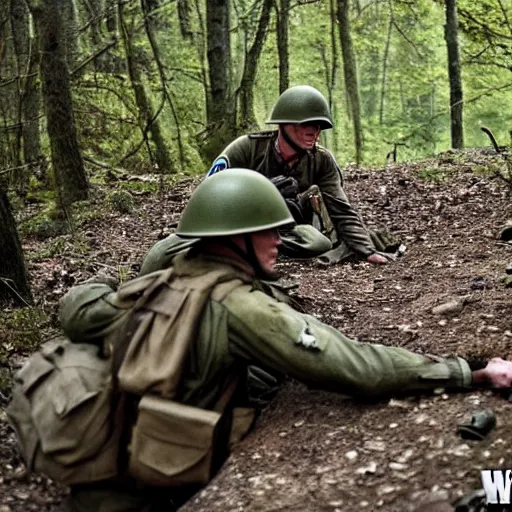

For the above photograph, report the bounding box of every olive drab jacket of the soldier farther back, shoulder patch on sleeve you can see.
[210,131,377,257]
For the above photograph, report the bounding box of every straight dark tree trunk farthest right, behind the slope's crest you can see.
[444,0,464,149]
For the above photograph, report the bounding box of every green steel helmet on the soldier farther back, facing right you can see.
[267,85,332,130]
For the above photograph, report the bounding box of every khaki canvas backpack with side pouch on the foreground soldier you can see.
[7,268,252,486]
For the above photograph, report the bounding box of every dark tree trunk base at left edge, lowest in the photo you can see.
[0,186,32,306]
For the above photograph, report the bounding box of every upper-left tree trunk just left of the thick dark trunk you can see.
[11,0,43,195]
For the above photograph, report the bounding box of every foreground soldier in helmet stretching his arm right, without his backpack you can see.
[46,169,512,512]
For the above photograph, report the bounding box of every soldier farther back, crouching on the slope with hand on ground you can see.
[144,85,399,272]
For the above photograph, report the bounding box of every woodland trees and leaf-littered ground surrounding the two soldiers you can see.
[0,4,512,512]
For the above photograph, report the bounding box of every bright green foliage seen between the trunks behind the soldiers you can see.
[0,0,512,178]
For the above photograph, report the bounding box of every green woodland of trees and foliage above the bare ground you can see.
[0,0,512,312]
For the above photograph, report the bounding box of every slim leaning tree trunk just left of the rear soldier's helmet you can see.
[239,0,274,130]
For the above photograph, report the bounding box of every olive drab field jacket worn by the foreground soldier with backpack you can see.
[62,254,471,408]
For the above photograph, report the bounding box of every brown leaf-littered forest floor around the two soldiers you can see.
[0,146,512,512]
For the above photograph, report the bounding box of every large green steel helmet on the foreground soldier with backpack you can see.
[176,169,294,238]
